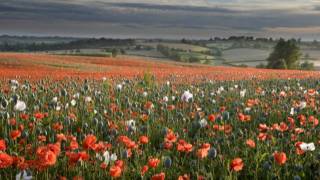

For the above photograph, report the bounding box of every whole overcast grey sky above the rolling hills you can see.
[0,0,320,40]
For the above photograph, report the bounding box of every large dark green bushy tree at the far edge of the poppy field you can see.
[267,38,301,69]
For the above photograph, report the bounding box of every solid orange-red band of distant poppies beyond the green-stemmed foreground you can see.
[0,53,320,82]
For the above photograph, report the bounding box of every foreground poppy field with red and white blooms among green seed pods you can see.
[0,54,320,180]
